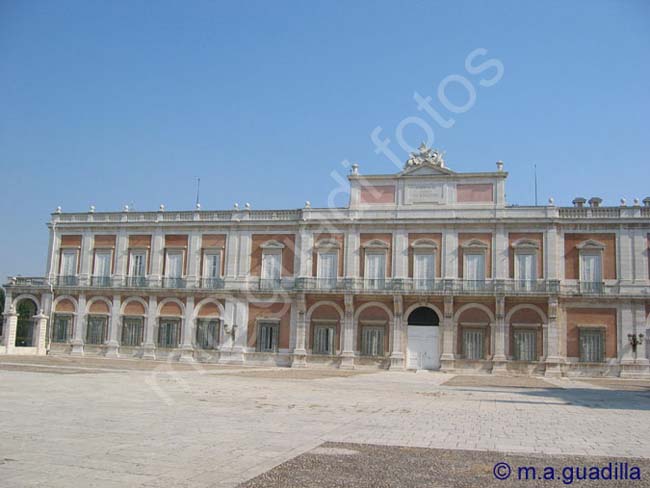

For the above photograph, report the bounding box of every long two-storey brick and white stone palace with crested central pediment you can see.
[0,146,650,377]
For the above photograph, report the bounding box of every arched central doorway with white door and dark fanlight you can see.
[407,306,440,369]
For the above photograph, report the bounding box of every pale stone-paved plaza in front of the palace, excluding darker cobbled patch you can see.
[0,357,650,488]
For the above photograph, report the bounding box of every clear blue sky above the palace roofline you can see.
[0,0,650,279]
